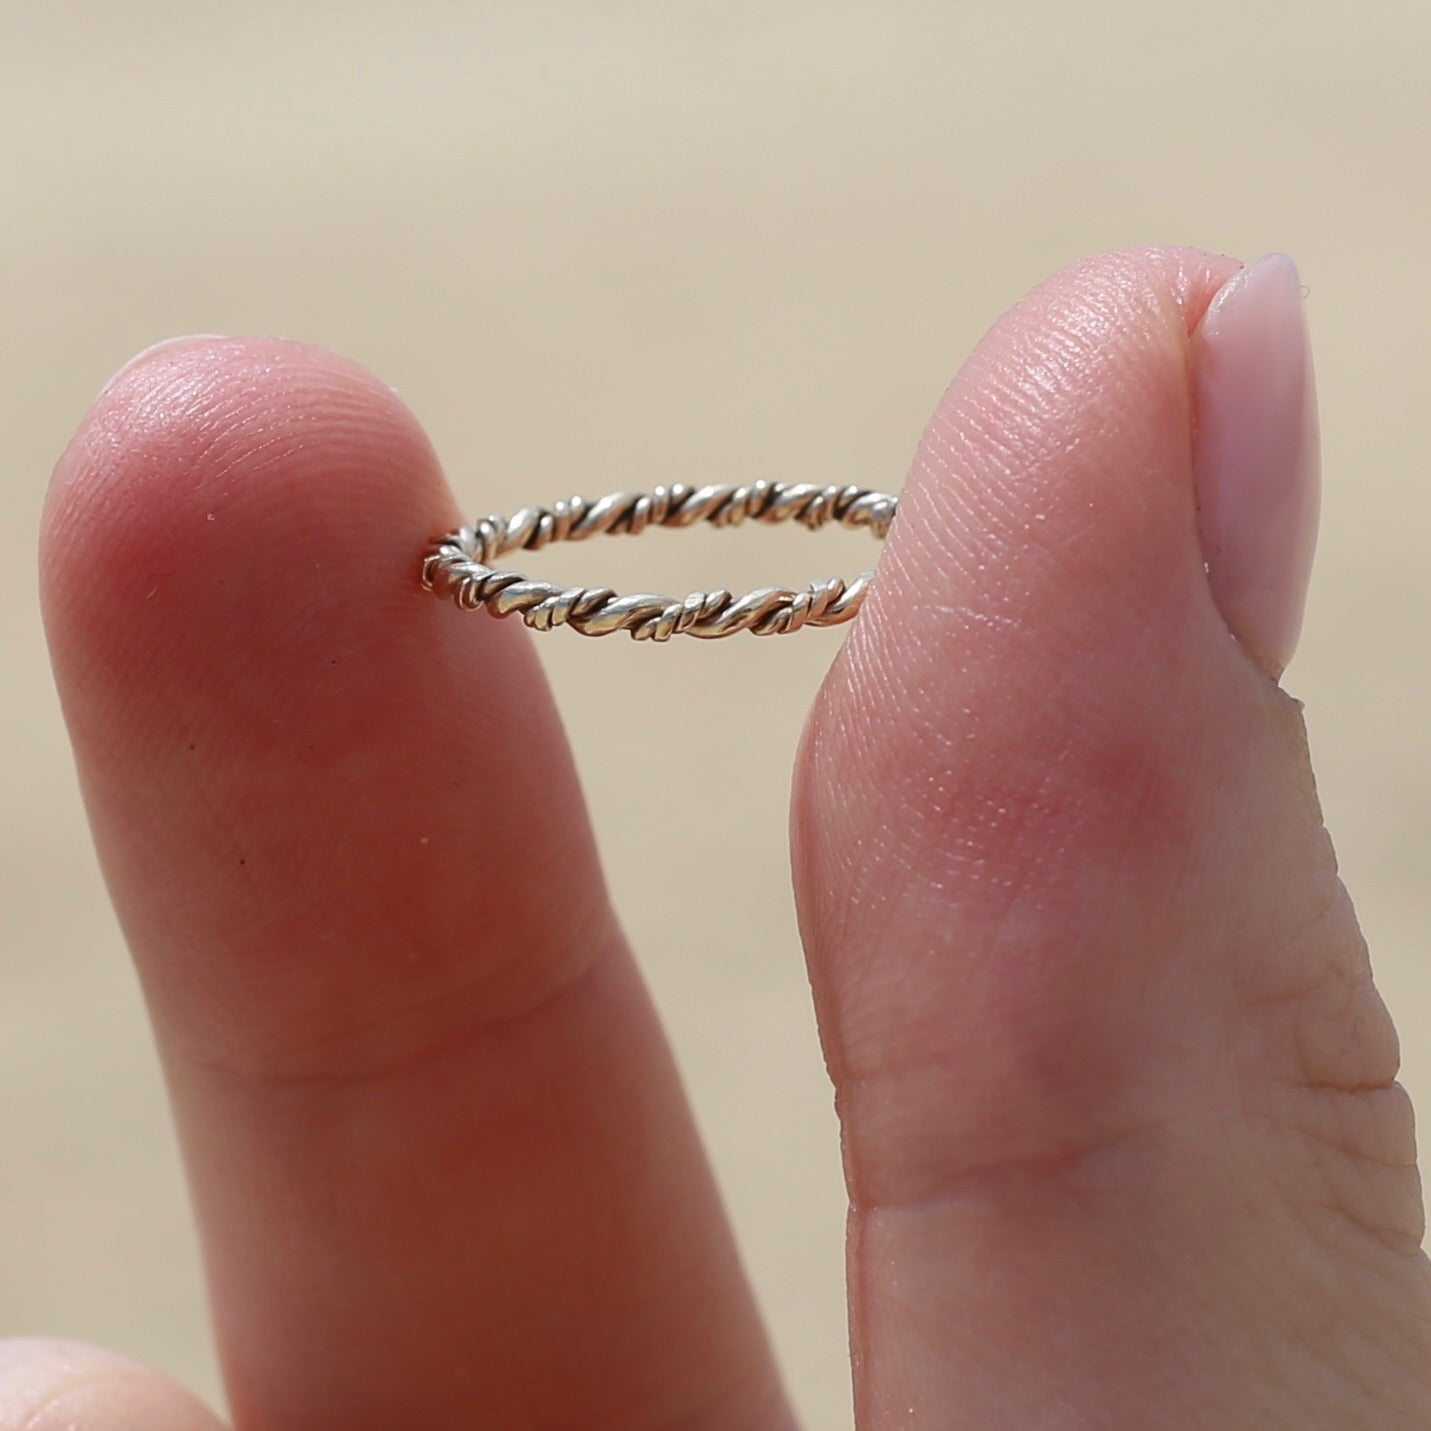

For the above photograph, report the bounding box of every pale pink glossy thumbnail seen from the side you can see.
[1193,253,1321,677]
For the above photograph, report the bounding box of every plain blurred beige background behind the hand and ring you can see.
[0,0,1431,1431]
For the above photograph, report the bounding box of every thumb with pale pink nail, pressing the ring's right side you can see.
[793,249,1431,1428]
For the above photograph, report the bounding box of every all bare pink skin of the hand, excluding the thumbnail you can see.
[27,249,1431,1431]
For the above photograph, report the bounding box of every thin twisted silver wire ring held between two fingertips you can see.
[422,481,897,641]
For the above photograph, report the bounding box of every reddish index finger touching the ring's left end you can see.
[43,341,786,1431]
